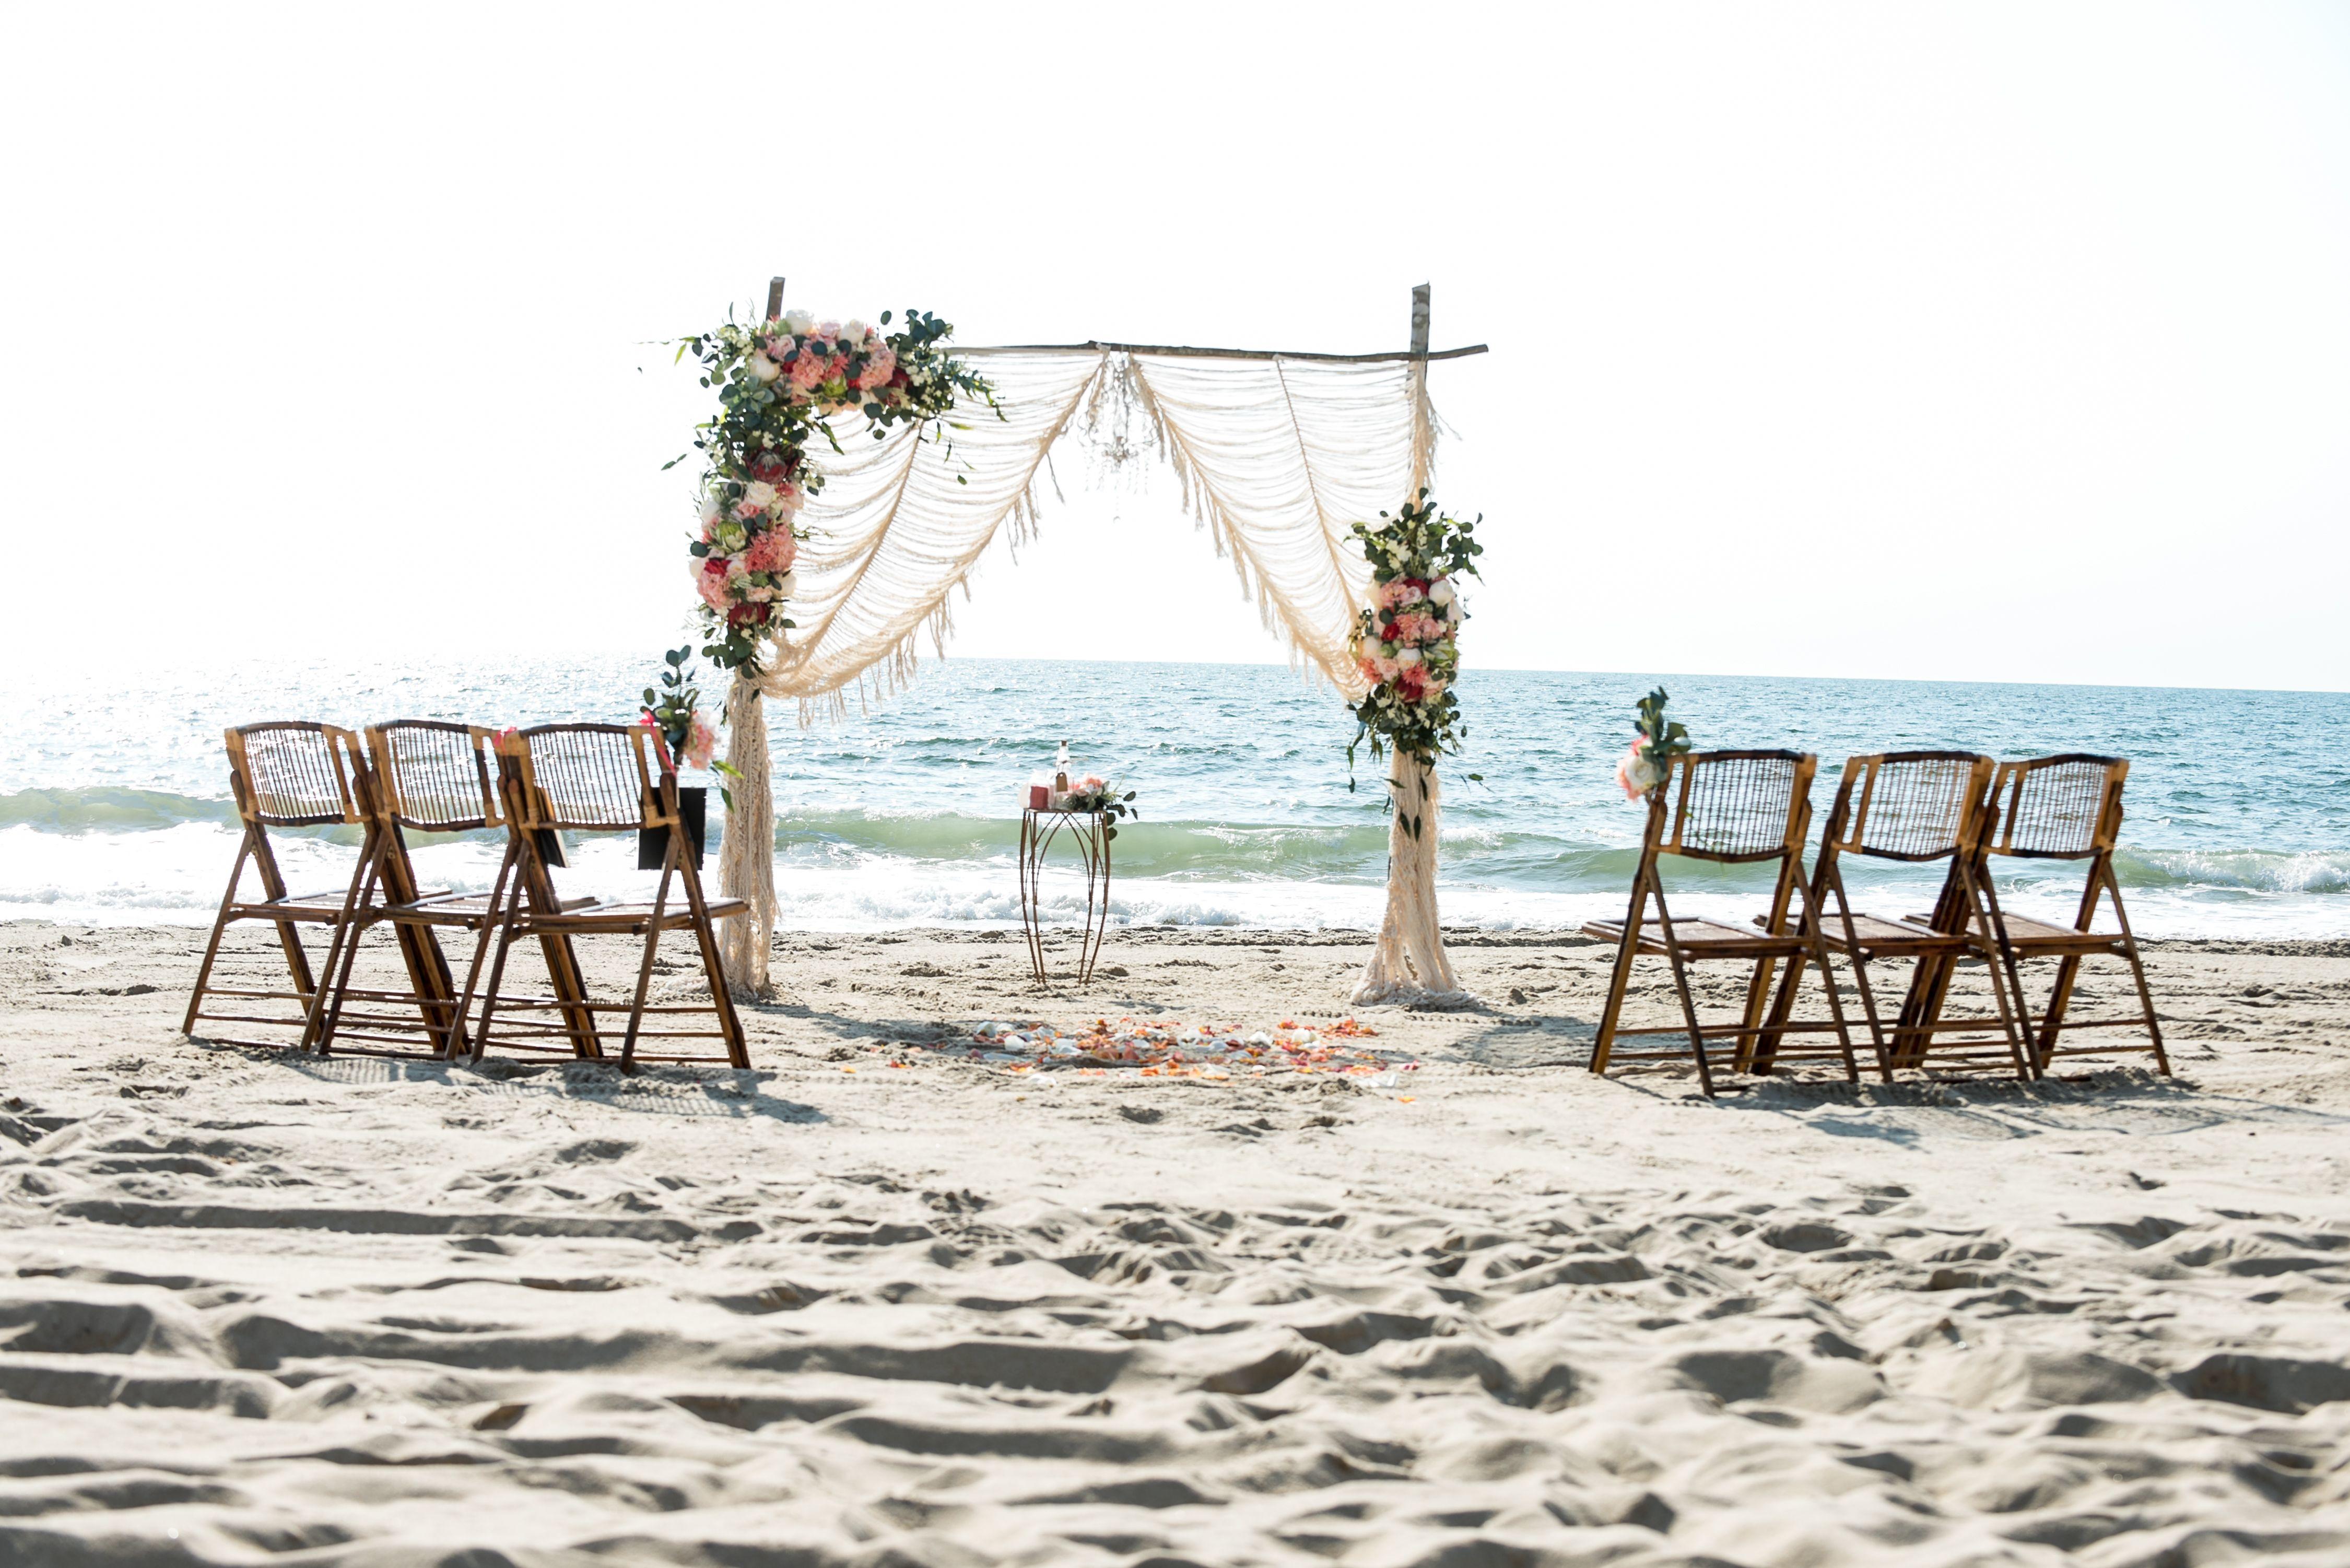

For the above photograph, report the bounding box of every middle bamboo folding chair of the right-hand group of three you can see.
[1758,752,2033,1079]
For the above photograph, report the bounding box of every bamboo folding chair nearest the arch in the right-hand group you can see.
[1584,752,1861,1098]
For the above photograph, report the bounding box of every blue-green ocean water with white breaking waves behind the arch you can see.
[0,658,2350,938]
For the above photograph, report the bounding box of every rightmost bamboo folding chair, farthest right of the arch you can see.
[1967,752,2171,1077]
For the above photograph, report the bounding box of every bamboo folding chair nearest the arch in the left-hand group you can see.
[473,724,750,1072]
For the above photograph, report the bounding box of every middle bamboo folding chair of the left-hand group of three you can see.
[313,720,515,1058]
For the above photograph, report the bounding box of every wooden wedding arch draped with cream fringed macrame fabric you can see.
[700,277,1485,1001]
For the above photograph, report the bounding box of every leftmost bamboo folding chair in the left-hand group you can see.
[181,720,374,1051]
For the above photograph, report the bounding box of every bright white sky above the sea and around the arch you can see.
[0,0,2350,689]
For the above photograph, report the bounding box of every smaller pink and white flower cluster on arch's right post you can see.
[1347,489,1485,837]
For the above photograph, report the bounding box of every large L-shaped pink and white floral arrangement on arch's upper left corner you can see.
[665,310,994,670]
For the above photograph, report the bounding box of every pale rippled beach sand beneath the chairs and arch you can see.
[0,924,2350,1568]
